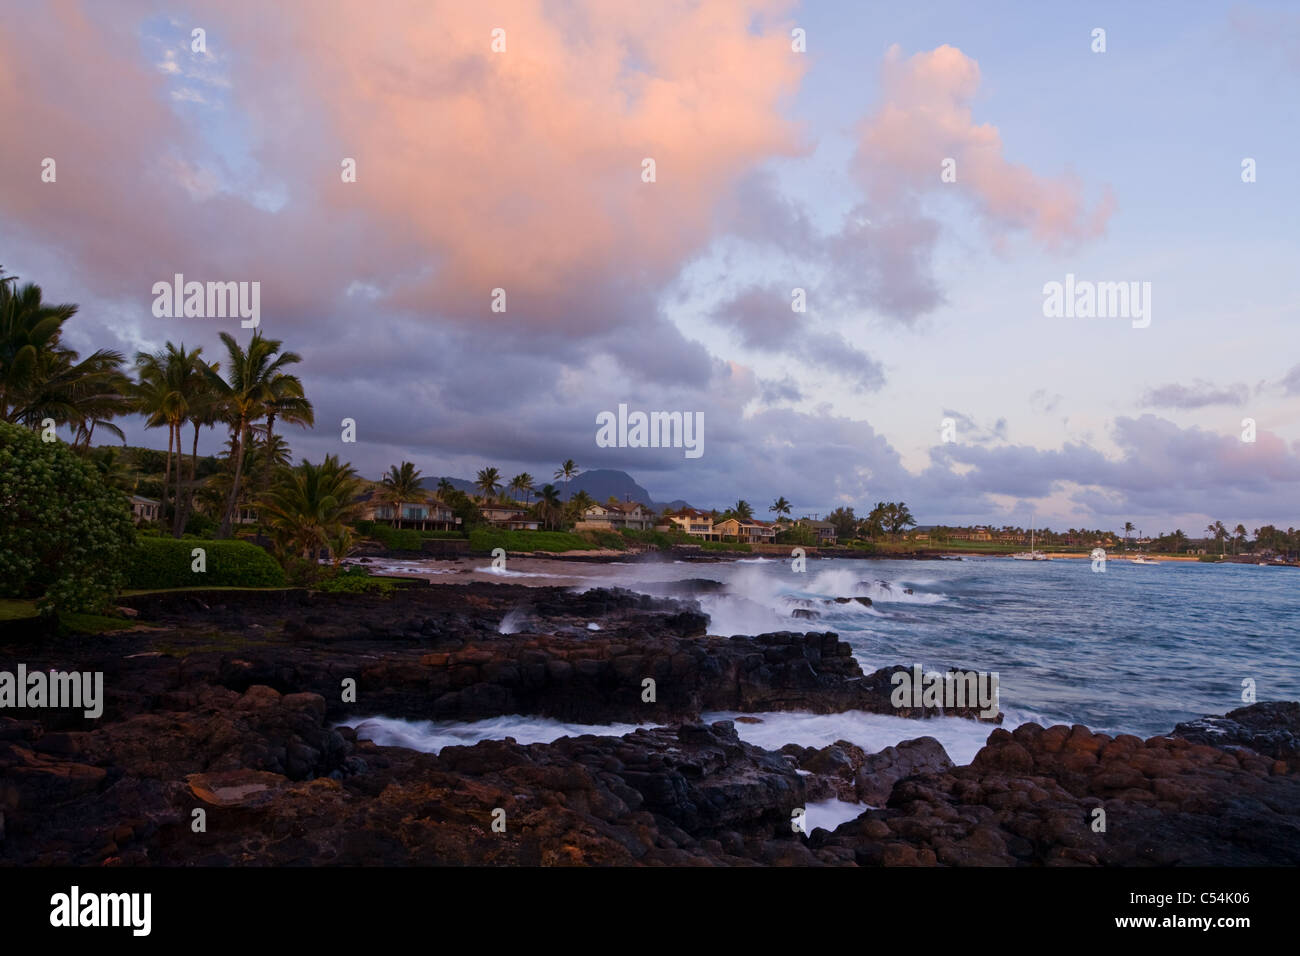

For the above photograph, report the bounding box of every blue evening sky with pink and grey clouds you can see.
[0,0,1300,533]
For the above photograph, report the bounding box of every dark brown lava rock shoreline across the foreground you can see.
[0,583,1300,866]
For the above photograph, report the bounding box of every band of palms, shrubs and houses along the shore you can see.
[0,261,1300,617]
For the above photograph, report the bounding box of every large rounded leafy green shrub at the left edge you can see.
[0,423,135,613]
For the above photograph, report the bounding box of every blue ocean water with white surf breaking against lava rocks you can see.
[345,557,1300,763]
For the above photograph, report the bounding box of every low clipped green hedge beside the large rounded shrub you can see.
[126,537,285,589]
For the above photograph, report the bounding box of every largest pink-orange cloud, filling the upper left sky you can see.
[0,0,806,333]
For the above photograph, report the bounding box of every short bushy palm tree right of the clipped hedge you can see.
[259,455,361,576]
